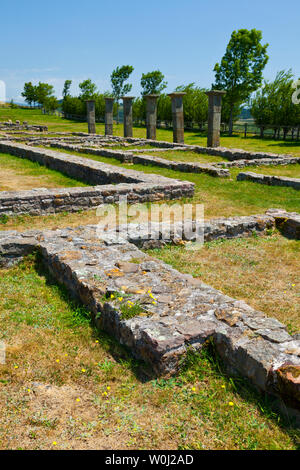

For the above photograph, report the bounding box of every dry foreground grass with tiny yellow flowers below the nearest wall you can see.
[0,256,300,450]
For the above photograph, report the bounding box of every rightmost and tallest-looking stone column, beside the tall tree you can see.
[205,90,226,147]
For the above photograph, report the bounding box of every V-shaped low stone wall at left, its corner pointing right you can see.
[0,142,194,215]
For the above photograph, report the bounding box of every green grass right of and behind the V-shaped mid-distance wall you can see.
[47,146,300,218]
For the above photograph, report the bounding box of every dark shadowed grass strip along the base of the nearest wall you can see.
[31,252,300,436]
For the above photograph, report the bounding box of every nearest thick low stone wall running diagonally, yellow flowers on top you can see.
[0,216,300,417]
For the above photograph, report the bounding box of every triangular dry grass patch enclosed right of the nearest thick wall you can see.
[148,231,300,334]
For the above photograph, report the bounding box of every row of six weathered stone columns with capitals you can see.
[86,90,225,147]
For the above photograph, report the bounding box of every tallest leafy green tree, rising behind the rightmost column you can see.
[213,29,268,135]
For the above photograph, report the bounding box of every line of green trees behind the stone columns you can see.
[22,29,300,136]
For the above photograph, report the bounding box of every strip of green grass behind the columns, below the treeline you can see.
[0,108,300,156]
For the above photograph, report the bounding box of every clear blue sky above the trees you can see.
[0,0,300,102]
